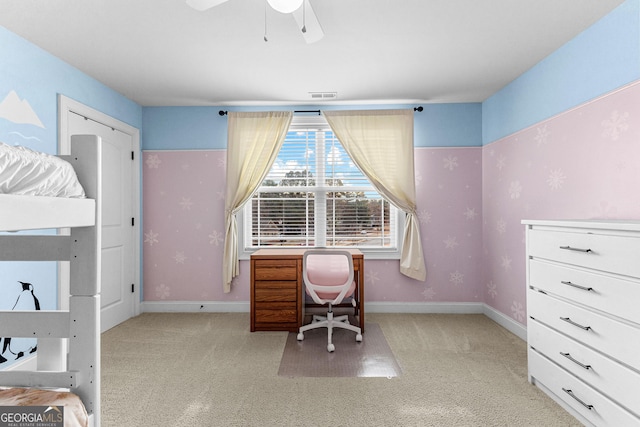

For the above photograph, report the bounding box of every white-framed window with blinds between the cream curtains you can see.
[242,116,401,258]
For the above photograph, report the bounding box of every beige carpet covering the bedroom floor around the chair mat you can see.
[102,313,580,427]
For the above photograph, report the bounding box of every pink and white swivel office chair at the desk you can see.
[298,249,362,352]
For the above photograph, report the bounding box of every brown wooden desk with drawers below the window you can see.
[251,248,364,332]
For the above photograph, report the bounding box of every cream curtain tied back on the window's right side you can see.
[323,110,427,281]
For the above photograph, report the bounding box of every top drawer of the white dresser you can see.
[528,228,640,277]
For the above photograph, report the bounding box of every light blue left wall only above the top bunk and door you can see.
[0,27,142,153]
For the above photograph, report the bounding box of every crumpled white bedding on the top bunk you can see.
[0,142,86,198]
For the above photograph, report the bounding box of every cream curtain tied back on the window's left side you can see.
[222,111,293,292]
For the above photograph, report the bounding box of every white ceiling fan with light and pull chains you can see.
[186,0,324,43]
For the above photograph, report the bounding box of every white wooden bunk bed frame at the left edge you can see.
[0,135,102,427]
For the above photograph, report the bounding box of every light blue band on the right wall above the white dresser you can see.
[482,0,640,145]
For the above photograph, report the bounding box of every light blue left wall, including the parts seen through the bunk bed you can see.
[0,27,142,350]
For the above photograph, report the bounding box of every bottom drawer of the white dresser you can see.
[529,349,640,427]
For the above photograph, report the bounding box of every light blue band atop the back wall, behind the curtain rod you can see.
[142,103,482,150]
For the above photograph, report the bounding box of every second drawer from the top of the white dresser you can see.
[529,259,640,324]
